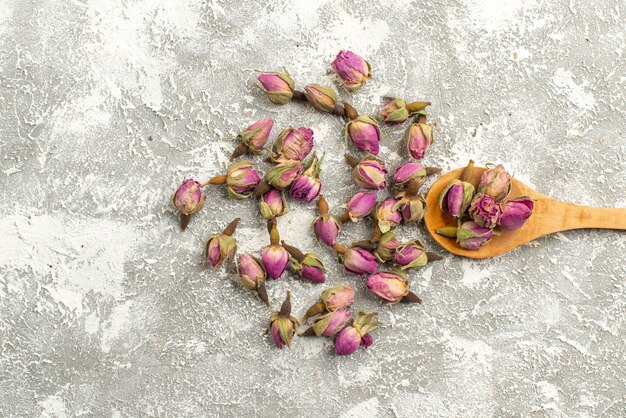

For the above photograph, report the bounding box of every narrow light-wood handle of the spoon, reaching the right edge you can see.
[541,199,626,232]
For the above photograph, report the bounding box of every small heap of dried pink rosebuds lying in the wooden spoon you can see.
[437,160,534,250]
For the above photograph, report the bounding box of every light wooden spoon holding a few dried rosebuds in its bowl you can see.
[424,167,626,258]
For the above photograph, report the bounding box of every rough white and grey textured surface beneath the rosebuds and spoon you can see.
[0,0,626,417]
